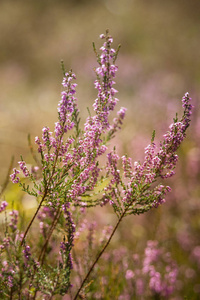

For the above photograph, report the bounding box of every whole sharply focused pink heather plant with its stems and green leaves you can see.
[0,31,192,299]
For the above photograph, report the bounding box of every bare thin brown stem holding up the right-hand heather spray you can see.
[73,208,127,300]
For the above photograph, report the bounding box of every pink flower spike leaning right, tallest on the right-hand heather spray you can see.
[135,93,192,183]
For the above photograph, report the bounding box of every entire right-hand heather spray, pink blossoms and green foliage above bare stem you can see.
[103,93,192,216]
